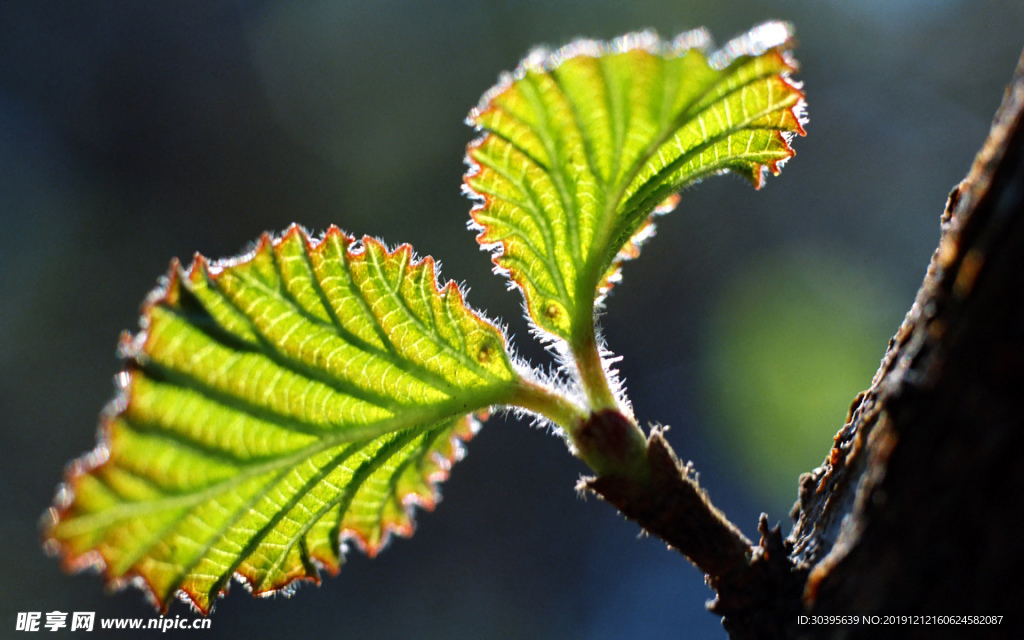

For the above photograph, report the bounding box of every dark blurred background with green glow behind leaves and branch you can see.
[0,0,1024,639]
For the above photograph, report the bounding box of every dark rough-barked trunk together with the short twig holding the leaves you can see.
[581,46,1024,640]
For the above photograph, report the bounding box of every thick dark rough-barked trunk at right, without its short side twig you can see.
[790,47,1024,639]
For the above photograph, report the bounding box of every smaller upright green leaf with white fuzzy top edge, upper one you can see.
[465,23,804,339]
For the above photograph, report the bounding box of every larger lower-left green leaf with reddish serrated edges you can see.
[46,226,526,611]
